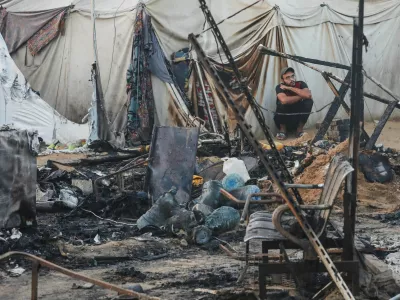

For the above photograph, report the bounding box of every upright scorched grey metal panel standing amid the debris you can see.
[146,127,199,204]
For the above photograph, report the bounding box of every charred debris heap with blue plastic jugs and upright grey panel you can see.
[0,127,400,256]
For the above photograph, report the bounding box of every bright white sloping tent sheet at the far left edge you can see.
[0,35,89,143]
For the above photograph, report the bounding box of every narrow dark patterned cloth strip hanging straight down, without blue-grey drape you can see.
[126,5,154,145]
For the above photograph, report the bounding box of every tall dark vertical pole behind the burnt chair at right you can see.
[343,0,364,260]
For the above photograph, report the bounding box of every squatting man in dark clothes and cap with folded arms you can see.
[274,67,313,140]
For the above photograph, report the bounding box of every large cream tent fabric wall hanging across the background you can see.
[0,0,400,138]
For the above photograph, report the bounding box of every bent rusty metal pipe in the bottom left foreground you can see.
[0,251,160,300]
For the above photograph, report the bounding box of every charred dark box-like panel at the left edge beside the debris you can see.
[0,128,37,228]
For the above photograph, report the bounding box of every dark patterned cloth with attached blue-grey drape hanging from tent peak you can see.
[126,4,190,145]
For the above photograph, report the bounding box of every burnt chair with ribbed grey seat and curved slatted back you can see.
[244,155,359,299]
